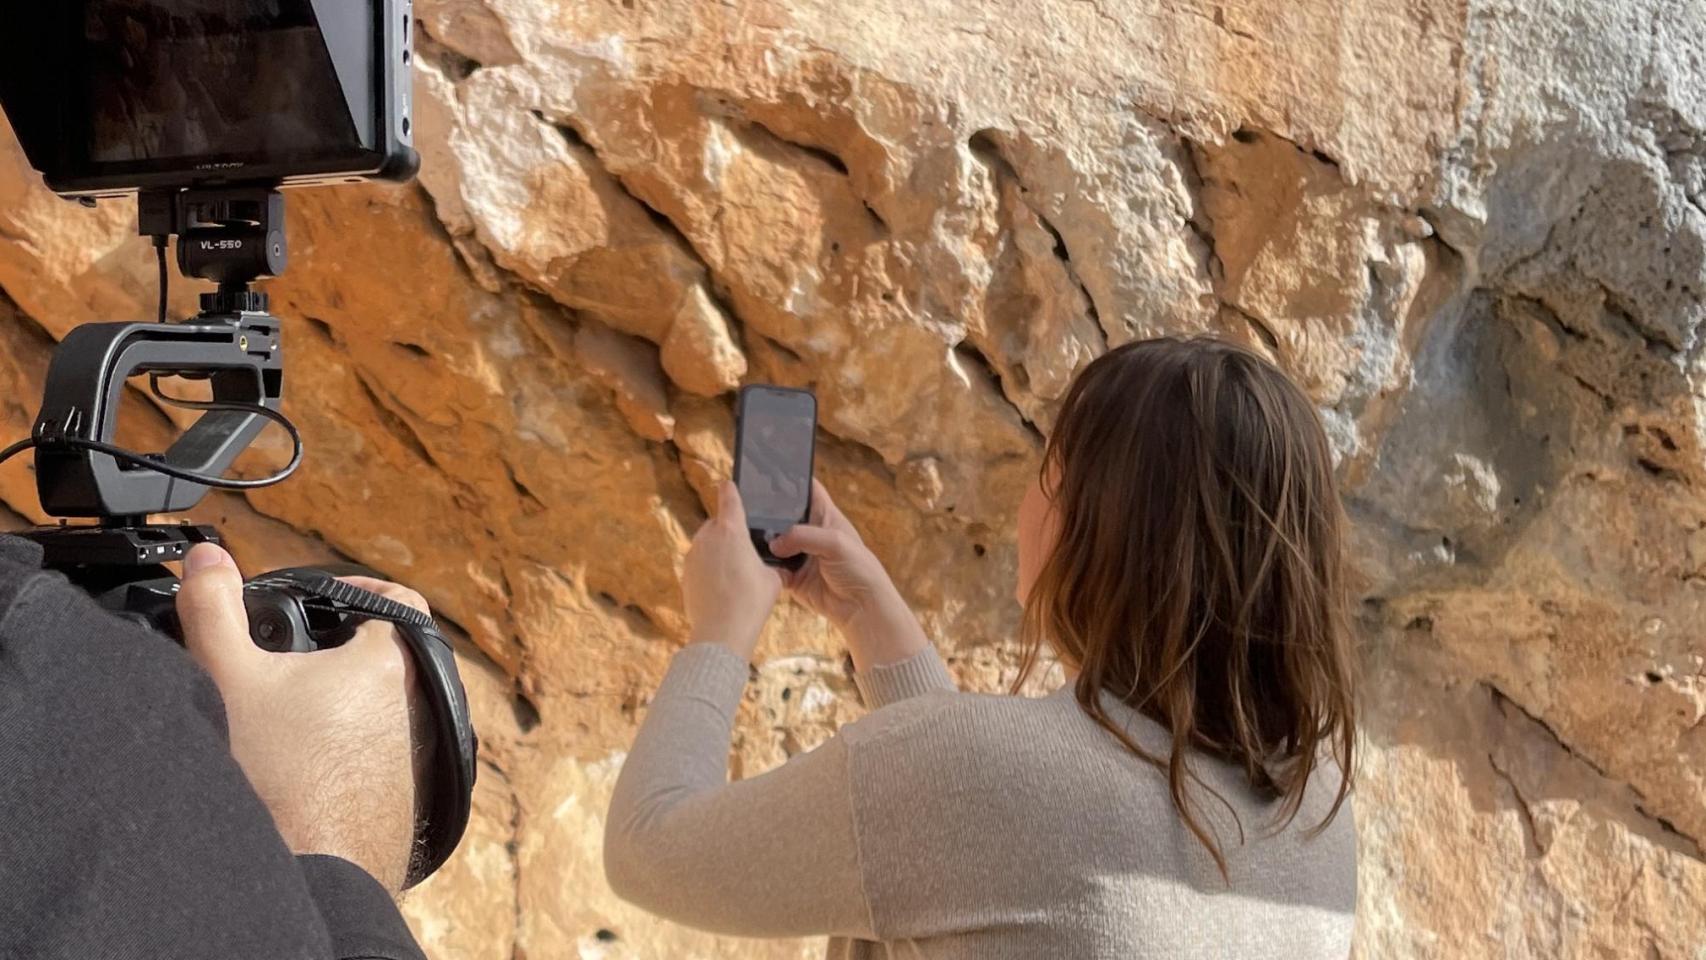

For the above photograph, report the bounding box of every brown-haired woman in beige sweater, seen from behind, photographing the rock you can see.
[606,339,1356,960]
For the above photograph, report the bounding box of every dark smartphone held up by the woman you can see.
[735,384,817,570]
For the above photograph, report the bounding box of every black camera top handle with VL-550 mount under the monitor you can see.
[31,186,288,527]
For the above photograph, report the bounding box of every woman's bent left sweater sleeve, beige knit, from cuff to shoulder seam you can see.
[604,645,873,940]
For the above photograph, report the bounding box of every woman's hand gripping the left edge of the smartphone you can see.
[681,481,781,660]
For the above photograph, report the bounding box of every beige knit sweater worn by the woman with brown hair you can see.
[604,645,1356,960]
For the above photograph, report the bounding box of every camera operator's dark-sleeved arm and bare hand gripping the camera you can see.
[0,537,427,960]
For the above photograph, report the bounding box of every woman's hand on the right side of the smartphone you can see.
[769,479,930,672]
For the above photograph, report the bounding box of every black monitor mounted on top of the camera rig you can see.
[0,0,420,196]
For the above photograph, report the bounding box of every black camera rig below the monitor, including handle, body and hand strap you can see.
[0,186,478,885]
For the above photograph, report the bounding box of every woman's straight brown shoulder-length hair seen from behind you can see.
[1015,338,1356,878]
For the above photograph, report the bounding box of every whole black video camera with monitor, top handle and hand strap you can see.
[0,0,478,885]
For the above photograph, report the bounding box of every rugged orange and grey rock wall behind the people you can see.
[0,0,1706,960]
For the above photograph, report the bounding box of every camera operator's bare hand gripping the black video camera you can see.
[177,544,427,892]
